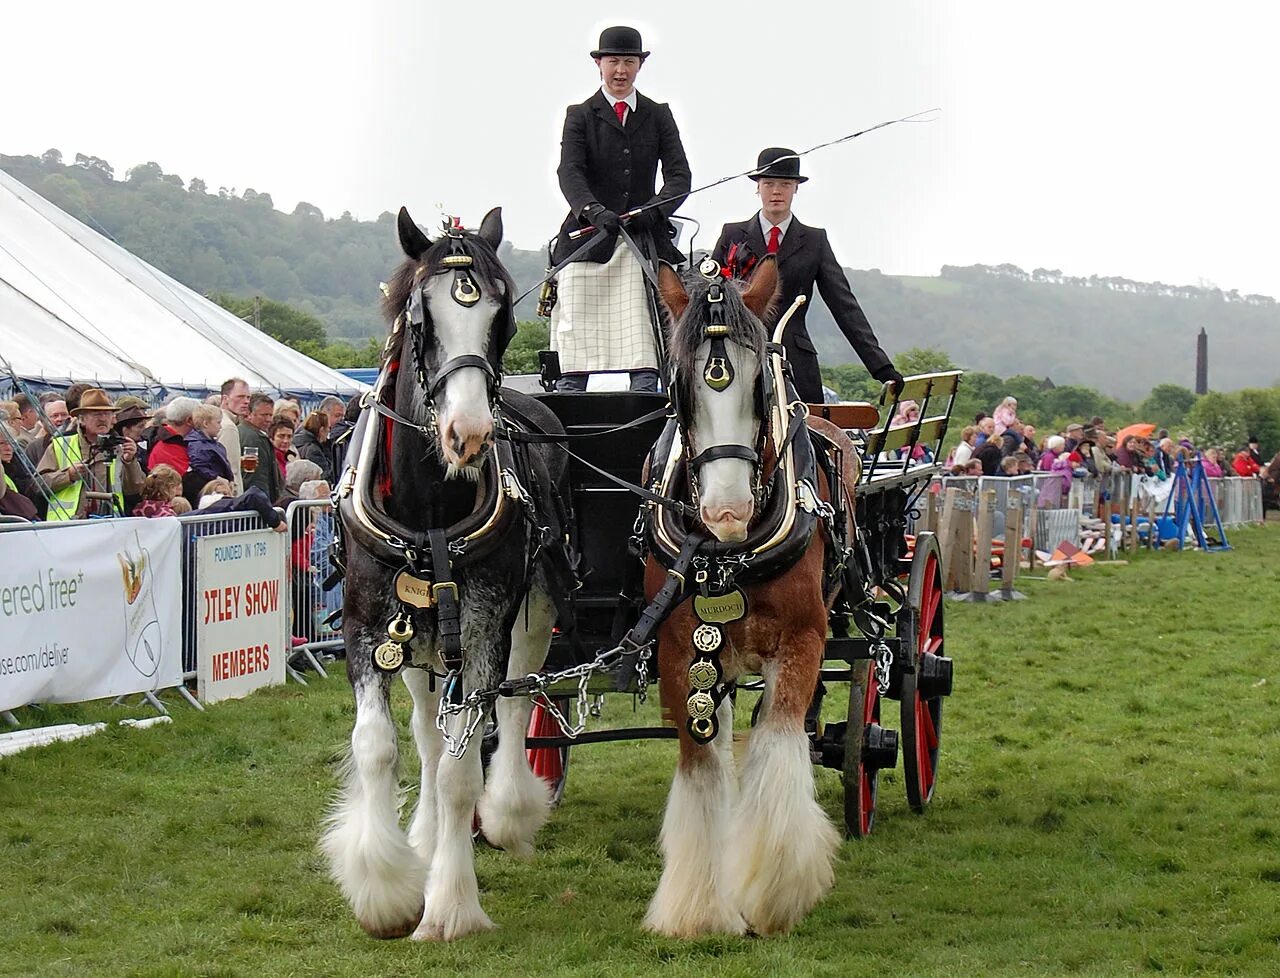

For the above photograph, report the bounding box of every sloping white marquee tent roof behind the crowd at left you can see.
[0,170,365,399]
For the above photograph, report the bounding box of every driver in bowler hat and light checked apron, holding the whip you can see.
[552,27,691,389]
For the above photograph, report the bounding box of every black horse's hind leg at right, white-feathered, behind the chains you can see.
[480,588,556,856]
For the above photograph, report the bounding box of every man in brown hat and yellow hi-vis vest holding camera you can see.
[40,387,145,521]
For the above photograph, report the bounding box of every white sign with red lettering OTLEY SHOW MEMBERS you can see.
[195,530,289,703]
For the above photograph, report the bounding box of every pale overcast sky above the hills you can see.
[0,0,1280,296]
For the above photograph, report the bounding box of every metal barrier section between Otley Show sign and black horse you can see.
[284,499,343,672]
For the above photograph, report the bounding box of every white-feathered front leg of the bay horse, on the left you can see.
[644,747,746,937]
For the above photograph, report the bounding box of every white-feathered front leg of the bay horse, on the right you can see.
[724,716,840,934]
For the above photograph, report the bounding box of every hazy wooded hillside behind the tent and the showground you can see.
[0,150,1280,399]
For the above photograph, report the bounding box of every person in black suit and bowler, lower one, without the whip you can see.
[712,146,902,403]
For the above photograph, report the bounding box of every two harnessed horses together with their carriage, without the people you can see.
[324,211,959,940]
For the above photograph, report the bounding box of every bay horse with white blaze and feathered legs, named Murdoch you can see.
[645,259,858,937]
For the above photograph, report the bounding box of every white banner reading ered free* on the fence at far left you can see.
[0,518,182,709]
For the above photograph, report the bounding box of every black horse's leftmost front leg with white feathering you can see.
[320,677,426,933]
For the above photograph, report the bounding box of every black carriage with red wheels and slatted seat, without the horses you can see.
[514,363,959,837]
